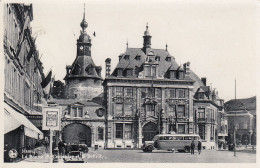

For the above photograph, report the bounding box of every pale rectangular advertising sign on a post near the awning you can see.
[42,106,61,130]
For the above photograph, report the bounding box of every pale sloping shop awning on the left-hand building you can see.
[4,103,43,139]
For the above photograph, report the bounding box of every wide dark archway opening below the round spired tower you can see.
[62,123,91,146]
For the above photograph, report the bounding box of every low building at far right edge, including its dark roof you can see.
[225,96,257,145]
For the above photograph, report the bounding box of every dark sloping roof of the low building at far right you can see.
[224,96,256,115]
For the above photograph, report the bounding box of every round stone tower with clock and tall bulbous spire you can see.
[64,6,102,100]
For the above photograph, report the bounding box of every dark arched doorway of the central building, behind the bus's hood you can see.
[142,122,159,142]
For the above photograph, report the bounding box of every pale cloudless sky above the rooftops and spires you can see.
[25,0,259,101]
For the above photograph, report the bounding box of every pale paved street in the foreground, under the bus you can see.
[22,148,256,163]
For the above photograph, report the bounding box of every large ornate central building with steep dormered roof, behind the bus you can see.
[103,25,226,148]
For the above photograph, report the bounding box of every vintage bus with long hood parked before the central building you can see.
[142,134,200,152]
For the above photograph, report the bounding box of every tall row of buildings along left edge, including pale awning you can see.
[3,4,44,159]
